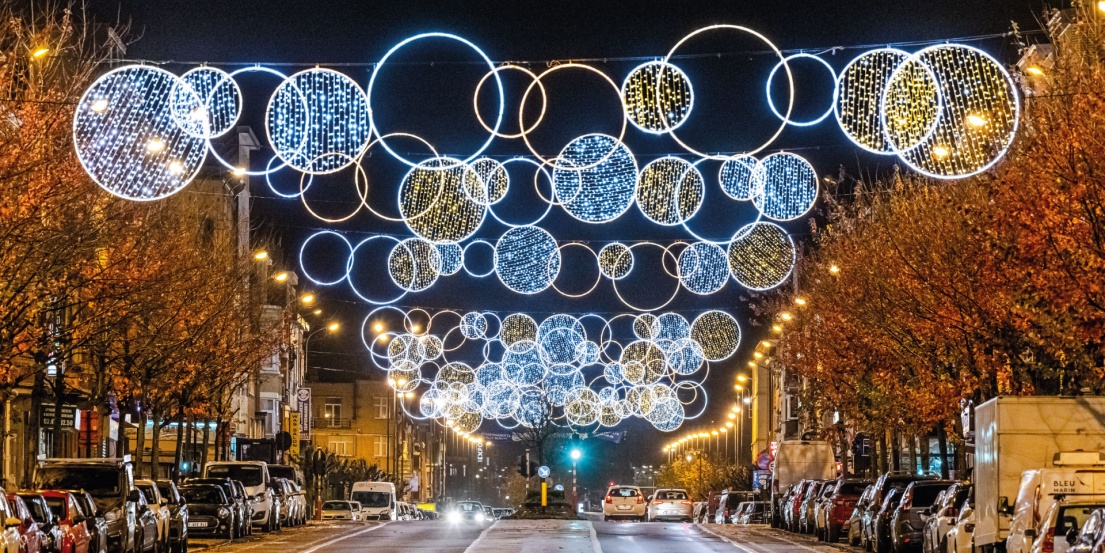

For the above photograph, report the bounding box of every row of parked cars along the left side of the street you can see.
[15,458,308,553]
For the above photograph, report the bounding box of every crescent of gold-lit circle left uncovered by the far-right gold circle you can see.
[833,48,909,154]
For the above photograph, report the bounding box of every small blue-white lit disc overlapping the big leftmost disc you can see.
[172,66,242,138]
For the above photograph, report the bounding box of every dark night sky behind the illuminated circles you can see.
[92,0,1044,481]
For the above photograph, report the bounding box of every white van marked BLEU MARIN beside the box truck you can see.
[1006,451,1105,553]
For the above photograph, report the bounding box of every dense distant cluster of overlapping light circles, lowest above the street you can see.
[361,307,740,432]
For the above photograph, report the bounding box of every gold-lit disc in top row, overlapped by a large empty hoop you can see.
[621,62,694,134]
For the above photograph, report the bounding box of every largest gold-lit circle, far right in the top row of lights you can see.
[883,44,1020,179]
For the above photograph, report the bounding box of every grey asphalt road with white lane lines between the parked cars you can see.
[192,520,844,553]
